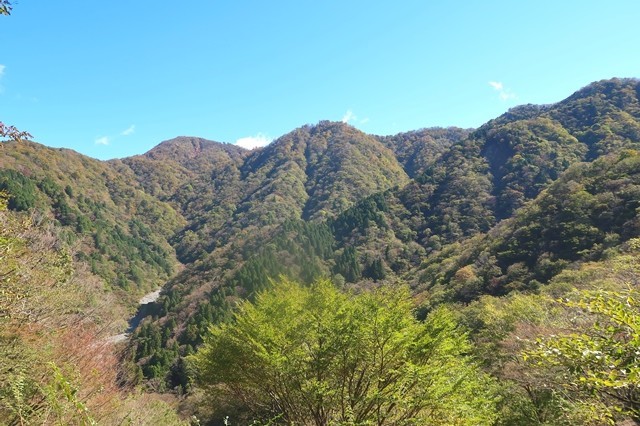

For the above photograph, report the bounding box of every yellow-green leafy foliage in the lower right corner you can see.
[524,288,640,421]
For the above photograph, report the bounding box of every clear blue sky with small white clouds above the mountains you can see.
[0,0,640,159]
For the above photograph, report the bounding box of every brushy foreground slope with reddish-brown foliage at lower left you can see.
[0,195,186,426]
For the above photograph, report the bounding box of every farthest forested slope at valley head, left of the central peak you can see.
[122,137,249,263]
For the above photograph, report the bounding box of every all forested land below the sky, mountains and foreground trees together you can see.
[0,79,640,425]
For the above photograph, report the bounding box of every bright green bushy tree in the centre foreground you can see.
[190,280,496,425]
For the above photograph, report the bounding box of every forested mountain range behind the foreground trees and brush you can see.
[0,79,640,416]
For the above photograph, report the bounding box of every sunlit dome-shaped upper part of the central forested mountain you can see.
[242,122,408,219]
